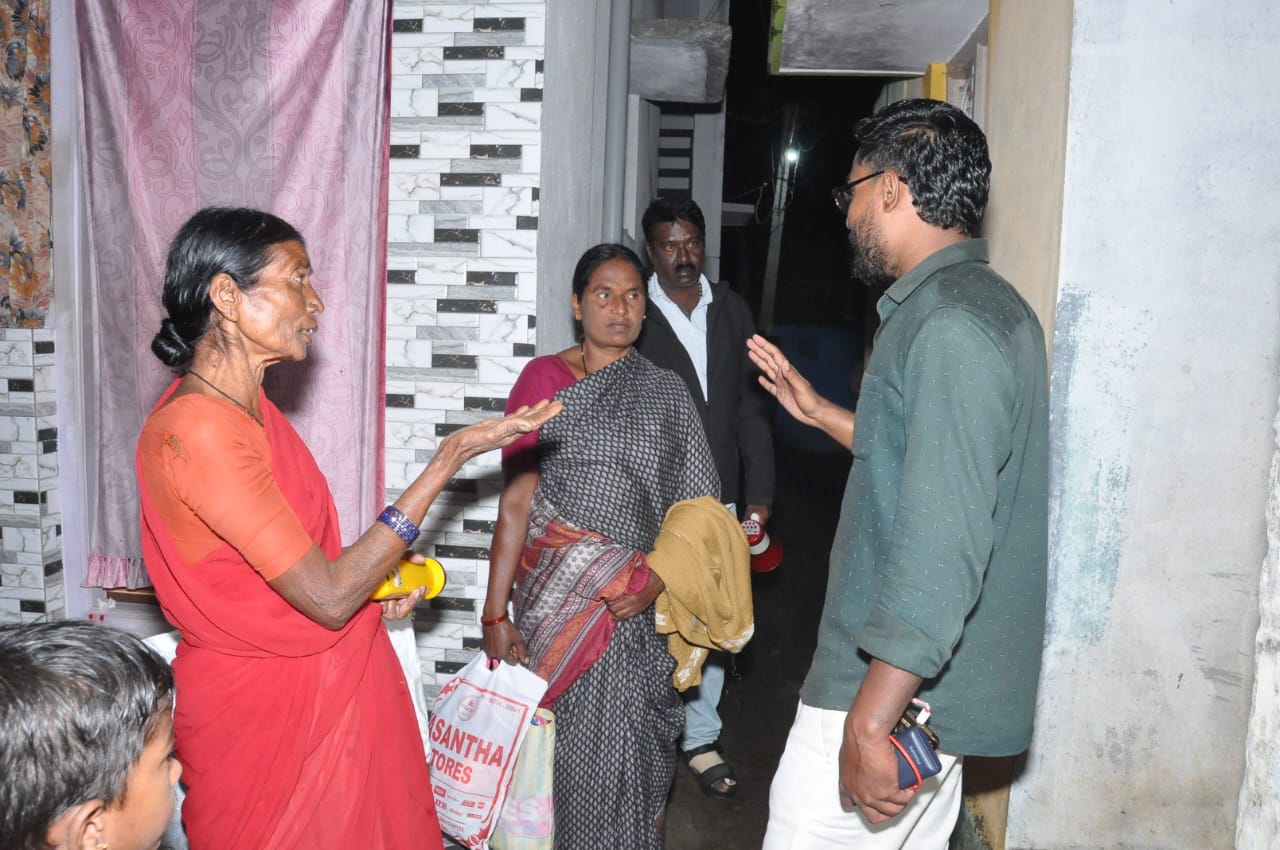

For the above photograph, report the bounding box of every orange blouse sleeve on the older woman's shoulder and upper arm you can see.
[138,396,315,581]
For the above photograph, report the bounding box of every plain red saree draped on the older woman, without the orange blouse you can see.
[138,384,443,850]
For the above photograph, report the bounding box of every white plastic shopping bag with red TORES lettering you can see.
[430,652,547,850]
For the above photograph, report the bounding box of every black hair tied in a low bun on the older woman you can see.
[151,206,306,370]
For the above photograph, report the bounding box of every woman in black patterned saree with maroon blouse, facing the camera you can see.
[481,245,719,850]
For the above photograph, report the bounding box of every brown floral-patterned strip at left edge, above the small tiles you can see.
[0,0,52,328]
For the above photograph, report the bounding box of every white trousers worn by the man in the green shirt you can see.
[764,703,964,850]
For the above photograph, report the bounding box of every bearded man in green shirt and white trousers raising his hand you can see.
[749,100,1048,850]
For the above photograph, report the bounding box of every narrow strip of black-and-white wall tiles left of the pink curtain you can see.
[0,328,67,623]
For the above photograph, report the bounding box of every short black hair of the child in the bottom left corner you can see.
[0,621,174,850]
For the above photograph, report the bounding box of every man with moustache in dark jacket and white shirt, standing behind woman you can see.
[636,198,773,798]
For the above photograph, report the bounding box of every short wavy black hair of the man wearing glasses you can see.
[854,99,991,237]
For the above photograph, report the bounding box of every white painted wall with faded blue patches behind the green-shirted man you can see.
[1008,0,1280,849]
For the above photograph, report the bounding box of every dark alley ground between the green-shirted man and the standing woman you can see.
[667,440,849,850]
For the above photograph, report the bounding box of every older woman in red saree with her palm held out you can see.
[137,209,559,850]
